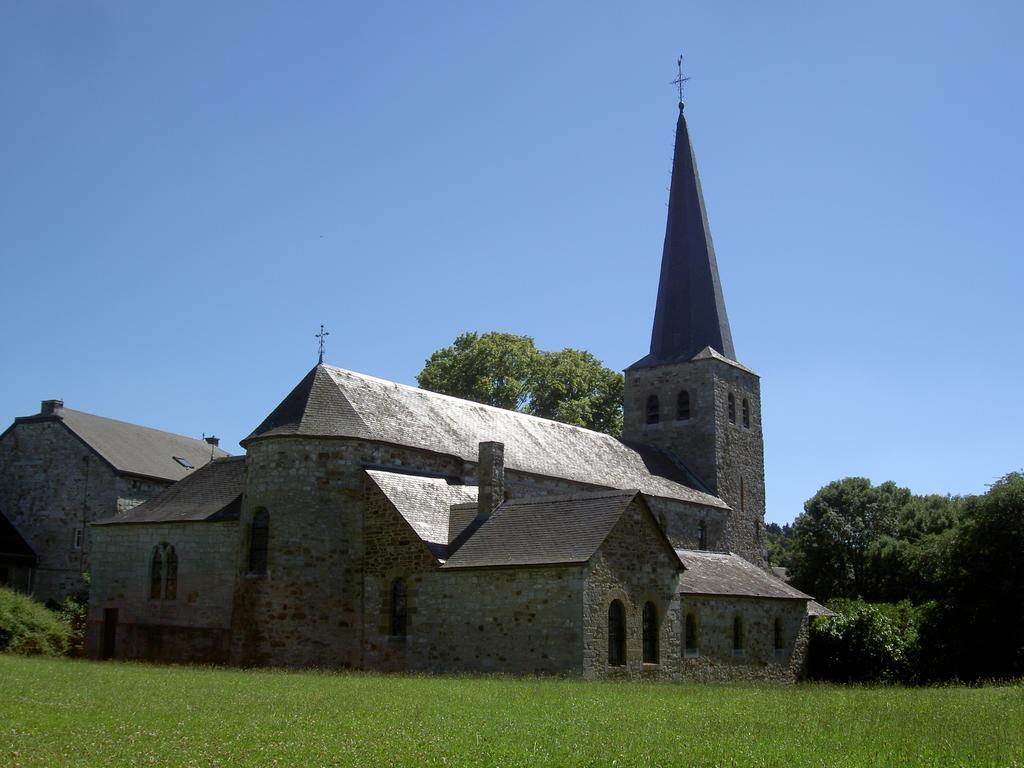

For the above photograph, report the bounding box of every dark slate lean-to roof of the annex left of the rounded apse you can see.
[92,456,246,525]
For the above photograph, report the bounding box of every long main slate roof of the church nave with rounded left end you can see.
[243,365,728,509]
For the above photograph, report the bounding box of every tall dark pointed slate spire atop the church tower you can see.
[630,102,736,368]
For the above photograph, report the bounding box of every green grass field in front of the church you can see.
[0,655,1024,768]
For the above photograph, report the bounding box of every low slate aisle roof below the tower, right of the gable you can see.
[676,549,811,600]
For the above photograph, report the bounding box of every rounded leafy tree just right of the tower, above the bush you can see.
[788,477,910,600]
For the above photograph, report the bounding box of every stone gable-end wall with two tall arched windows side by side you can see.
[583,501,681,680]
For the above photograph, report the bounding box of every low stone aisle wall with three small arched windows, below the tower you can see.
[680,595,807,682]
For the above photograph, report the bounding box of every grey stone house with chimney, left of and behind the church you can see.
[0,400,226,602]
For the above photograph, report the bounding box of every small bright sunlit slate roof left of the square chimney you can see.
[367,469,477,559]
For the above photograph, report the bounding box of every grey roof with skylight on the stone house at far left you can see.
[14,408,229,480]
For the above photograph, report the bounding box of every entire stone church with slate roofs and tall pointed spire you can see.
[88,104,809,680]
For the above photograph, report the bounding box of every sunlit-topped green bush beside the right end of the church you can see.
[807,600,919,682]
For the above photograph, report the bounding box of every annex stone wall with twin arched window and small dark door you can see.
[86,522,240,664]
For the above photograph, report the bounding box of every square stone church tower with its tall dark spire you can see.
[623,102,767,567]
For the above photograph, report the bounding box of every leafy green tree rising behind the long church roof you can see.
[417,332,625,435]
